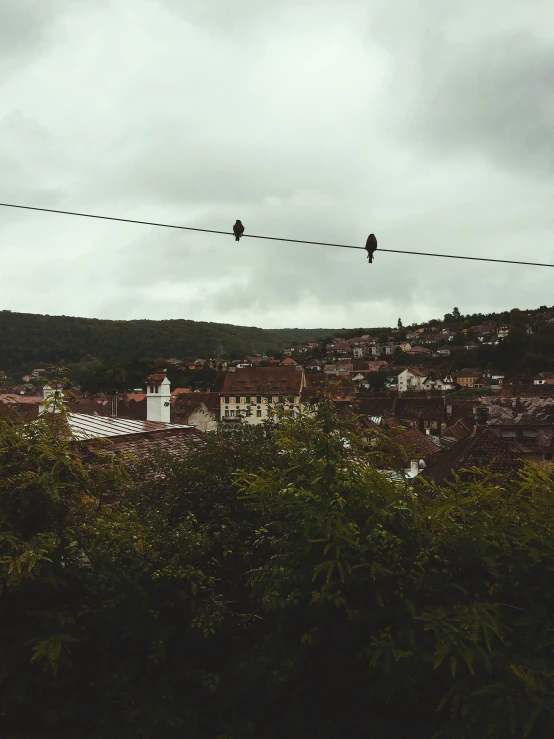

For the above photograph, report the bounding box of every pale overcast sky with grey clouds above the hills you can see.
[0,0,554,328]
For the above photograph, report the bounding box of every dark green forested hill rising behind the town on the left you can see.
[0,310,331,370]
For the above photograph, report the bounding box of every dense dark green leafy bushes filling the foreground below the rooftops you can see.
[0,401,554,739]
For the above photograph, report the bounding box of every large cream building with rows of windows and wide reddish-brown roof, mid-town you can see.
[219,365,305,425]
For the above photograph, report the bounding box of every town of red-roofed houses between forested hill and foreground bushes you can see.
[0,309,554,476]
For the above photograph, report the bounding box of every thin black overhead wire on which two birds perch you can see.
[0,203,554,267]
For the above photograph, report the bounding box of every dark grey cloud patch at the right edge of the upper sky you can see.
[416,34,554,175]
